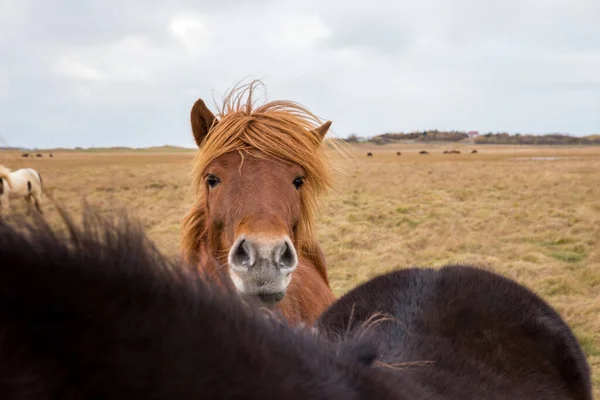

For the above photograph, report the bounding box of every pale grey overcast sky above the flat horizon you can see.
[0,0,600,148]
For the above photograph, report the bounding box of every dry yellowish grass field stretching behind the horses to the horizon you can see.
[0,144,600,397]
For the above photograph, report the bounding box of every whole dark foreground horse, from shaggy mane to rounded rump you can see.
[0,210,592,400]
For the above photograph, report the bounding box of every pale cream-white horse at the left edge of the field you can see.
[0,165,43,213]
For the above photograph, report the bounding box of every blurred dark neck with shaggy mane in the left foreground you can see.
[0,209,410,400]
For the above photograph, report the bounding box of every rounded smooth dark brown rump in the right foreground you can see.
[315,266,592,400]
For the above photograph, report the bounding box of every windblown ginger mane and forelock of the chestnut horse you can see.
[180,80,343,278]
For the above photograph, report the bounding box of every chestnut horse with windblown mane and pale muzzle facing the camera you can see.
[181,81,334,325]
